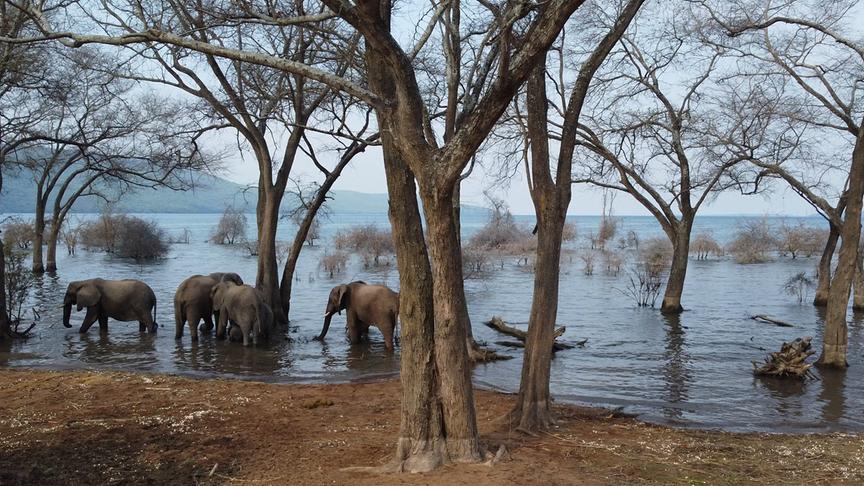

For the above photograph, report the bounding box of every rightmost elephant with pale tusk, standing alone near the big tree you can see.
[315,280,399,351]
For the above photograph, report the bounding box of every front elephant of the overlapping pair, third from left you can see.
[210,281,273,346]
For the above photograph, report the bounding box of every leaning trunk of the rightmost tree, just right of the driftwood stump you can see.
[818,128,864,368]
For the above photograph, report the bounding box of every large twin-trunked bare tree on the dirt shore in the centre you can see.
[6,0,583,470]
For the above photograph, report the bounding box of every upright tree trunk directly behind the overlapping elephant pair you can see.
[255,186,286,323]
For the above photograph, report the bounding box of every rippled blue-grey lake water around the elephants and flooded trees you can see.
[0,214,864,432]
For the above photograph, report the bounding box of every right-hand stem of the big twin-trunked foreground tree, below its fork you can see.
[420,187,482,462]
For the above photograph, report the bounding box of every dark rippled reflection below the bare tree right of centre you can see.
[663,314,692,419]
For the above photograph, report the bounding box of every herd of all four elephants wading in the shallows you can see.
[63,273,399,351]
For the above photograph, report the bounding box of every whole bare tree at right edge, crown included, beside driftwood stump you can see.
[700,0,864,367]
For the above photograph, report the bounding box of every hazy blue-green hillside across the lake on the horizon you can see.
[0,172,487,214]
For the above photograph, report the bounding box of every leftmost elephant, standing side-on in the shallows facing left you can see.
[63,278,158,333]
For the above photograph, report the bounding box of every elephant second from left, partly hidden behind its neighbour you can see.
[174,272,243,341]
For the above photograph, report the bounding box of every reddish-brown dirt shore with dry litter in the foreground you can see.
[0,370,864,486]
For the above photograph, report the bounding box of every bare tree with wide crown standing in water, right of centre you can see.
[574,4,783,313]
